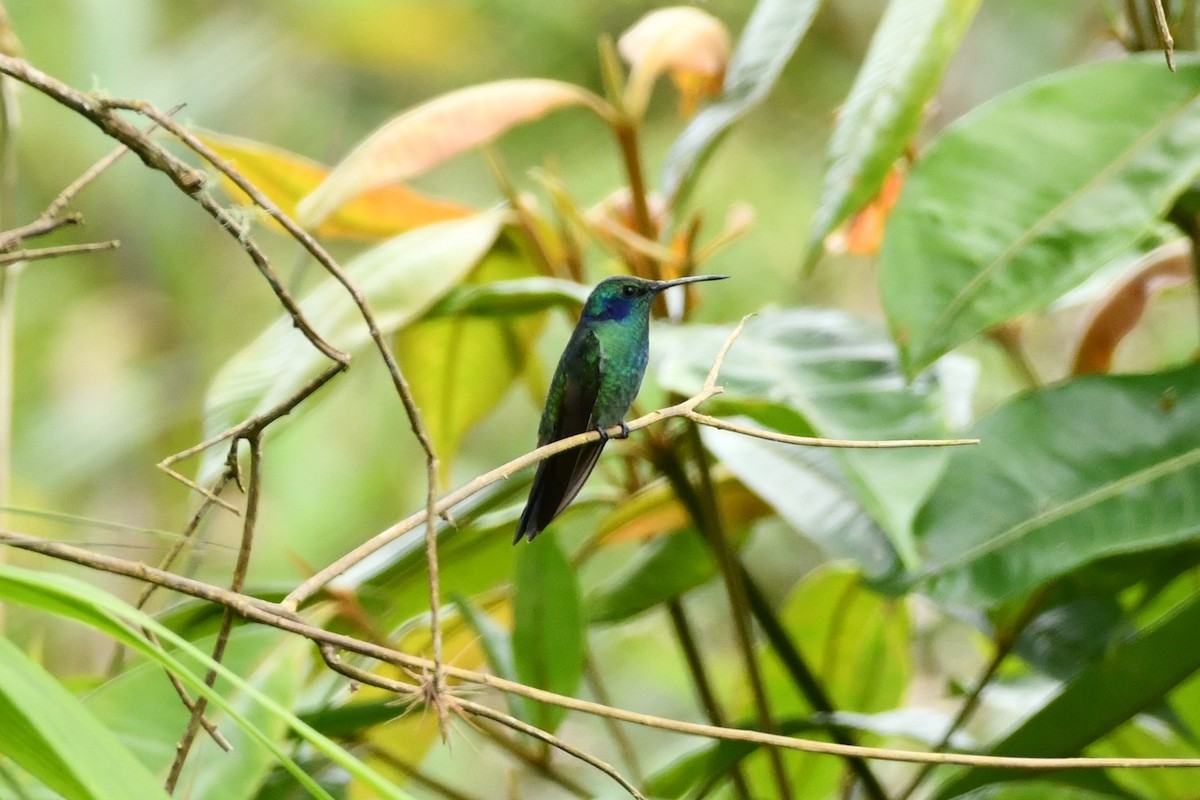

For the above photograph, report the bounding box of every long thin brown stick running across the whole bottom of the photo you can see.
[7,531,1200,770]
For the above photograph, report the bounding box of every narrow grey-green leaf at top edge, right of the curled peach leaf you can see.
[662,0,821,206]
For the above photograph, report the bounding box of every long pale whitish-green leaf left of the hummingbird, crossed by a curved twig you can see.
[199,210,505,483]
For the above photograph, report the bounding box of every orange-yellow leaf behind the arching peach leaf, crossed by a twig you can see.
[197,133,474,239]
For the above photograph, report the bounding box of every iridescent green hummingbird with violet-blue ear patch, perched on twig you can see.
[512,275,728,545]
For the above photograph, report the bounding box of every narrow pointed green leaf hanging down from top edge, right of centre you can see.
[806,0,979,264]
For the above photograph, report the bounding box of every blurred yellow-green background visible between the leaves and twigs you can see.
[5,0,1171,724]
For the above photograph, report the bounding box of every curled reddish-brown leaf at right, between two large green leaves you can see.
[1070,241,1193,375]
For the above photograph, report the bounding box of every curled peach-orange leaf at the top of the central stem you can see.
[617,6,731,116]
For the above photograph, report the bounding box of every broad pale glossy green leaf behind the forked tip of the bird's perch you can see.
[654,309,971,576]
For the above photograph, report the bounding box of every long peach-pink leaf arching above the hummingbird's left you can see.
[298,78,604,227]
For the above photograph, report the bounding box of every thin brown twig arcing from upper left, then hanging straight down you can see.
[107,101,448,740]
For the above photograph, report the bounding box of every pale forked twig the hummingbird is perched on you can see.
[282,317,978,612]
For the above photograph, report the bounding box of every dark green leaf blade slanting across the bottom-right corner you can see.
[934,585,1200,800]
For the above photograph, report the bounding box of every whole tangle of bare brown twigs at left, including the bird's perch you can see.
[0,55,1200,798]
